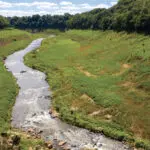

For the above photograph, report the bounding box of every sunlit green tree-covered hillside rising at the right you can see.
[67,0,150,33]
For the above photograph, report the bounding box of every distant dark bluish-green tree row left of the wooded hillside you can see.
[8,14,71,31]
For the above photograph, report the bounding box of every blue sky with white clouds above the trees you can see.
[0,0,118,17]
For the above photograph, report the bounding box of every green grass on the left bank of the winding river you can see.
[0,29,48,150]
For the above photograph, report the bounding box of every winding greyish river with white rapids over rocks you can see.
[5,38,130,150]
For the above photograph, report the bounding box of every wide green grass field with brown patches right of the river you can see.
[25,30,150,149]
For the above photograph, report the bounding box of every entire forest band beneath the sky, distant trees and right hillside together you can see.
[0,0,150,33]
